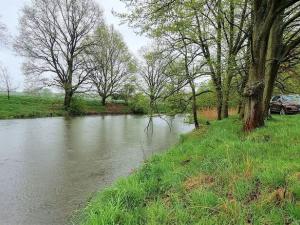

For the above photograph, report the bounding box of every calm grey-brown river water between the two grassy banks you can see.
[0,115,193,225]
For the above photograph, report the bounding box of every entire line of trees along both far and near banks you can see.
[2,0,300,131]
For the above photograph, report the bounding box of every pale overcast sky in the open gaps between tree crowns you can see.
[0,0,148,87]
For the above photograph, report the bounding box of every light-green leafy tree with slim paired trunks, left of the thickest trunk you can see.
[120,0,250,119]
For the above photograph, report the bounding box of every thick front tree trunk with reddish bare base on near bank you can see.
[244,0,277,132]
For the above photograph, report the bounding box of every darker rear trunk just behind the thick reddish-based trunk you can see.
[263,14,283,118]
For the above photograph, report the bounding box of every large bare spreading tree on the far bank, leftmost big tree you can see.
[15,0,102,109]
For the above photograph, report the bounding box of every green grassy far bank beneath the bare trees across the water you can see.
[0,95,130,119]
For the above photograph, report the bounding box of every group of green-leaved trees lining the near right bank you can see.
[120,0,300,131]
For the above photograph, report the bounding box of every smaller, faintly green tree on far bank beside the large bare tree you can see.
[86,25,135,105]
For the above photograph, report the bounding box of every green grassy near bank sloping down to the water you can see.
[75,116,300,225]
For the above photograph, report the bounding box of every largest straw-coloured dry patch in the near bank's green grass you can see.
[184,174,215,191]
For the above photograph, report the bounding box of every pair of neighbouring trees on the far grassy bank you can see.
[14,0,135,110]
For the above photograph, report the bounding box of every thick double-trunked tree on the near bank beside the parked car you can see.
[244,0,300,131]
